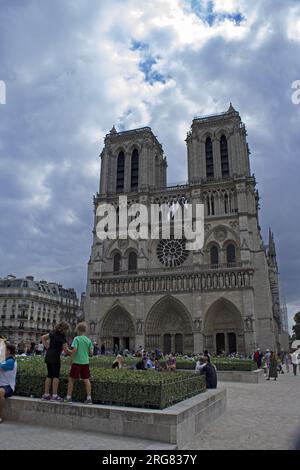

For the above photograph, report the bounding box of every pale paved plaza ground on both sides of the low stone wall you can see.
[0,373,300,450]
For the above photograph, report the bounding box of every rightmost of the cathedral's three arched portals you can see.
[203,299,245,354]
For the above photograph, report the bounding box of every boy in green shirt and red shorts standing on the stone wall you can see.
[66,323,94,405]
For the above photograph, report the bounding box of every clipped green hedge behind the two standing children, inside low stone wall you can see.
[15,358,205,409]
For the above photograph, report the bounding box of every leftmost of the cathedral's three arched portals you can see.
[100,305,135,352]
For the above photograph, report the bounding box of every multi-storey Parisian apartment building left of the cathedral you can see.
[0,275,83,346]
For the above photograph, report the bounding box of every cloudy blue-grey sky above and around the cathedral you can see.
[0,0,300,330]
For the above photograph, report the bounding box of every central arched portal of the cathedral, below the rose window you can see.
[145,296,194,353]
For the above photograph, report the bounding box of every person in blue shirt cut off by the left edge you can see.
[0,344,17,423]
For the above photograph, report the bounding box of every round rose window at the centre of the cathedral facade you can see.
[156,240,189,267]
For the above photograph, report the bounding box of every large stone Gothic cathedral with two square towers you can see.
[85,104,288,354]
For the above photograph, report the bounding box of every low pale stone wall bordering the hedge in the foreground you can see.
[5,390,226,448]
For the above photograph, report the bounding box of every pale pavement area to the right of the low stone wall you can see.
[186,372,300,450]
